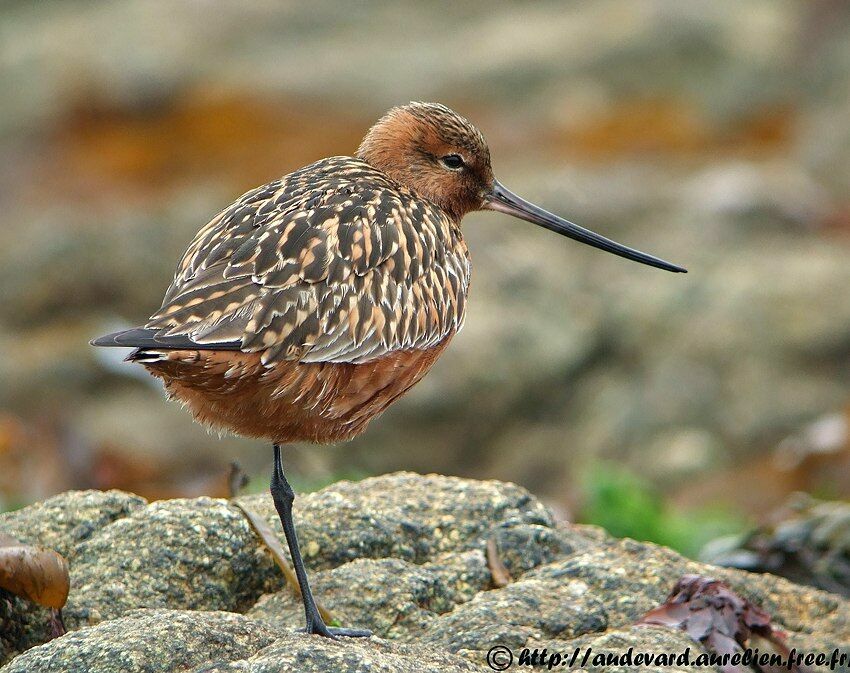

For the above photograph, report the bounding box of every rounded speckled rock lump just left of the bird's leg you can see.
[65,498,281,626]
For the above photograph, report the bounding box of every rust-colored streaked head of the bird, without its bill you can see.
[357,103,493,221]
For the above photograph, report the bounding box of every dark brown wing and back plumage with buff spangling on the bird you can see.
[146,157,470,365]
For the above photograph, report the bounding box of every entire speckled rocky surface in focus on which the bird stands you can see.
[0,474,850,673]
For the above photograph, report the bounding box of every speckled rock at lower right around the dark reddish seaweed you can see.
[428,538,850,661]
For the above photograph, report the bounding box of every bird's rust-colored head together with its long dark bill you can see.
[357,103,685,273]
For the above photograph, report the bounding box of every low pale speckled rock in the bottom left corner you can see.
[3,610,275,673]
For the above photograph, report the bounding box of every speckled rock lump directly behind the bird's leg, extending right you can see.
[235,473,552,568]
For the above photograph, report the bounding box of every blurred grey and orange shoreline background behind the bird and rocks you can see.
[0,0,850,554]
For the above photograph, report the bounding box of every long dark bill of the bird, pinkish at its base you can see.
[482,180,688,273]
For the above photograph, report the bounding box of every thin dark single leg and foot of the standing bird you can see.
[270,444,372,638]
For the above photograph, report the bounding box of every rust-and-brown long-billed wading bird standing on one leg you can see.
[91,102,686,638]
